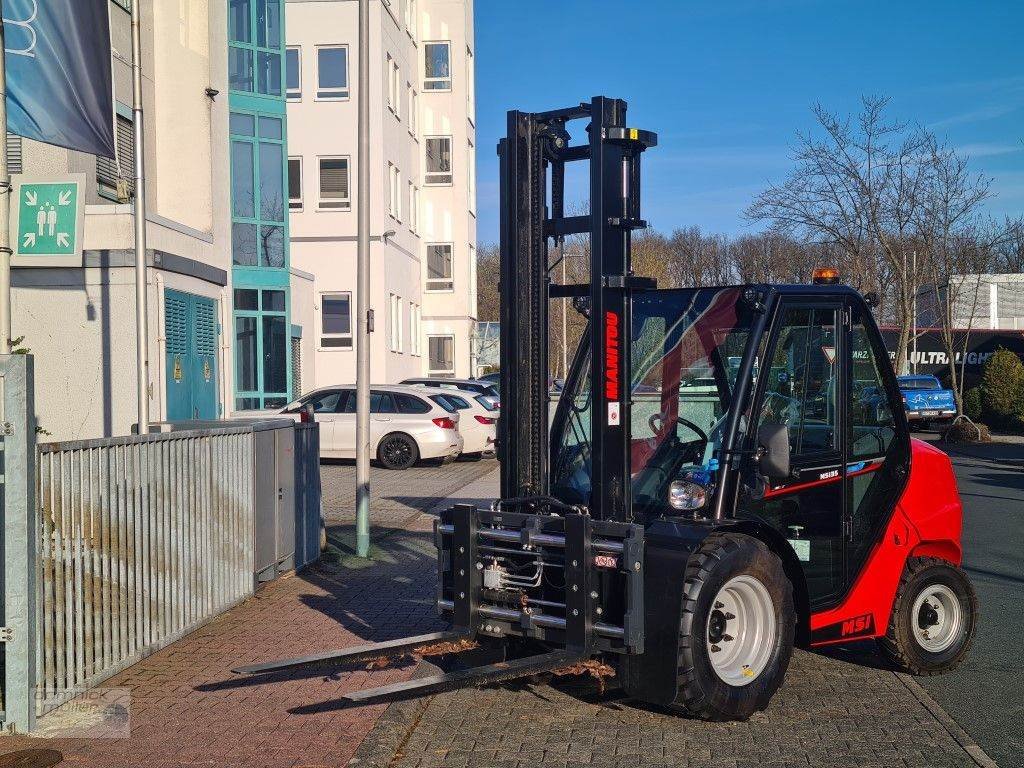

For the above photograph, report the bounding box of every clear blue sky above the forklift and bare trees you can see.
[475,0,1024,243]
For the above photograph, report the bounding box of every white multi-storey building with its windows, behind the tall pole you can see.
[286,0,476,390]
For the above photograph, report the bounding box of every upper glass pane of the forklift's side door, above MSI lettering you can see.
[758,307,839,456]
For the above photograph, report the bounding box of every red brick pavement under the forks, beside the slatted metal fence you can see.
[0,462,497,768]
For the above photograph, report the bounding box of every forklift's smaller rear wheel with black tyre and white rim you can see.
[879,557,978,675]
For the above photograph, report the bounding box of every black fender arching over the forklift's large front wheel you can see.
[618,519,810,706]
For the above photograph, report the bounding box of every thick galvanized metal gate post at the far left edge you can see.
[0,354,39,733]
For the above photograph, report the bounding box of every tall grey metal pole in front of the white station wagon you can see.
[355,0,371,557]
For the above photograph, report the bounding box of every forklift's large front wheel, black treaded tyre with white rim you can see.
[671,534,796,720]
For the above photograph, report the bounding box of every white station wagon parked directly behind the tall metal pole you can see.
[260,384,464,469]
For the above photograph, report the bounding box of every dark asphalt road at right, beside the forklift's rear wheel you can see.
[918,436,1024,768]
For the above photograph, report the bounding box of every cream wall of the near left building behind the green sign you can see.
[12,0,230,439]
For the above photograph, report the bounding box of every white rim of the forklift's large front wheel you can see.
[705,574,777,686]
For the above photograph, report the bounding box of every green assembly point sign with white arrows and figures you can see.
[11,174,85,266]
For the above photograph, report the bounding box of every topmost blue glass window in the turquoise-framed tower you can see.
[227,0,284,96]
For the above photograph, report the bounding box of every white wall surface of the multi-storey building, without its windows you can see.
[287,0,475,386]
